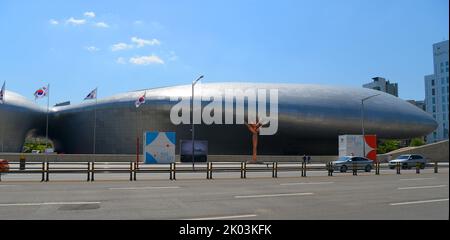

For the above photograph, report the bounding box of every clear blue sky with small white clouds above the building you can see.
[0,0,449,105]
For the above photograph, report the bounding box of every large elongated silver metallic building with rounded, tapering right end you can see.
[49,83,437,155]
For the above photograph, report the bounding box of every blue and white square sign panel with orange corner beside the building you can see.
[144,132,176,164]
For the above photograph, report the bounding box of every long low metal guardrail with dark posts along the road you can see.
[0,161,439,182]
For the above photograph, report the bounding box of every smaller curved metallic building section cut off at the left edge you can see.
[0,91,46,152]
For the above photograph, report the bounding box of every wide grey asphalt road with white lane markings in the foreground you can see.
[0,168,449,220]
